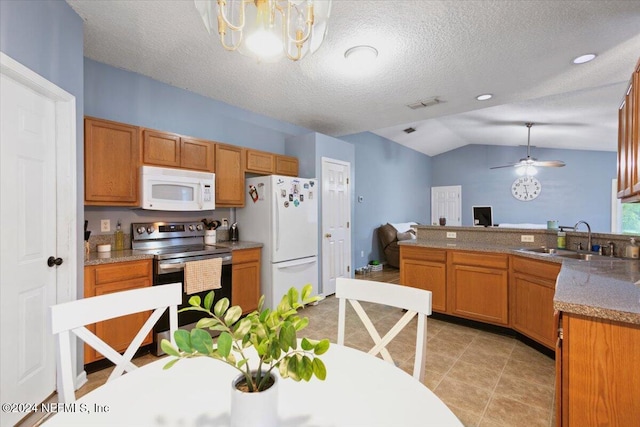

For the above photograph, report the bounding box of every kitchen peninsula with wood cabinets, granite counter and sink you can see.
[399,226,640,426]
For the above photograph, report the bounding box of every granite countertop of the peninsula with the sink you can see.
[398,239,640,325]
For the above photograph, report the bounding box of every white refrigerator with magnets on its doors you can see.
[236,175,319,309]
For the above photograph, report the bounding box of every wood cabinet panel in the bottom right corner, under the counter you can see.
[556,313,640,427]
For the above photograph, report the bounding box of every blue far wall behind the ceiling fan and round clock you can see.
[431,145,617,233]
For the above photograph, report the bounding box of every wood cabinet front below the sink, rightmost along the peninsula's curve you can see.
[509,256,561,348]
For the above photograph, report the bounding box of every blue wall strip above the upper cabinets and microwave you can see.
[84,58,311,154]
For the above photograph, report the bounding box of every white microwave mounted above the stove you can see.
[140,166,216,211]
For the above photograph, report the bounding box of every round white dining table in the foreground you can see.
[44,343,462,427]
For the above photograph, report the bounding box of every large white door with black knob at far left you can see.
[0,51,77,425]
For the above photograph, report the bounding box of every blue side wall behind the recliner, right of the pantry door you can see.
[341,132,432,268]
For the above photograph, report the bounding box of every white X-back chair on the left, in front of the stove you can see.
[50,283,182,403]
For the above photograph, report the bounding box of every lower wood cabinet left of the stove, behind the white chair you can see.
[84,260,153,364]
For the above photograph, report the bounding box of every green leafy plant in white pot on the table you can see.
[161,284,330,425]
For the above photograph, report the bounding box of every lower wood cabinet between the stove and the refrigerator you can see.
[231,248,261,314]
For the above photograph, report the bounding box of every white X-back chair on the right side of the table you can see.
[336,278,431,382]
